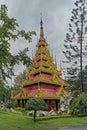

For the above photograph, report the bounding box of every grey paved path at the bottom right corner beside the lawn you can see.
[52,125,87,130]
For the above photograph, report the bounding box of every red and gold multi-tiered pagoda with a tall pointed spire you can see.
[11,19,69,111]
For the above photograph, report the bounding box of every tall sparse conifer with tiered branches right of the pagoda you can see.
[63,0,87,92]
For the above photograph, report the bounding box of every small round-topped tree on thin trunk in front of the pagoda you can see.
[26,97,48,122]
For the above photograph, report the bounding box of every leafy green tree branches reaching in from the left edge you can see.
[0,5,35,80]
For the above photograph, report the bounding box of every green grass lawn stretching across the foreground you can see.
[0,111,87,130]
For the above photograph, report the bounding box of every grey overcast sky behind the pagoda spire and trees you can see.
[0,0,75,76]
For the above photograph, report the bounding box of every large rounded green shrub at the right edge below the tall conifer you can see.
[70,93,87,116]
